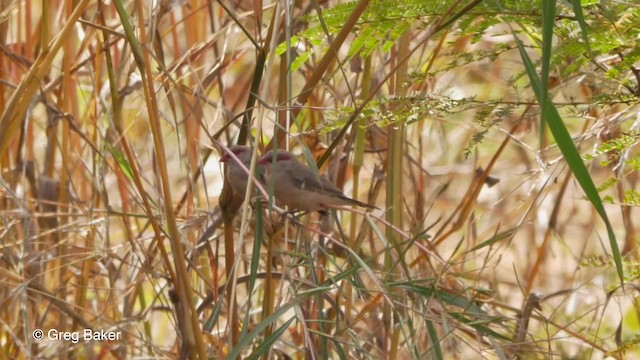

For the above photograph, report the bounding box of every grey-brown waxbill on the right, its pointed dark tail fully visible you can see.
[258,150,376,213]
